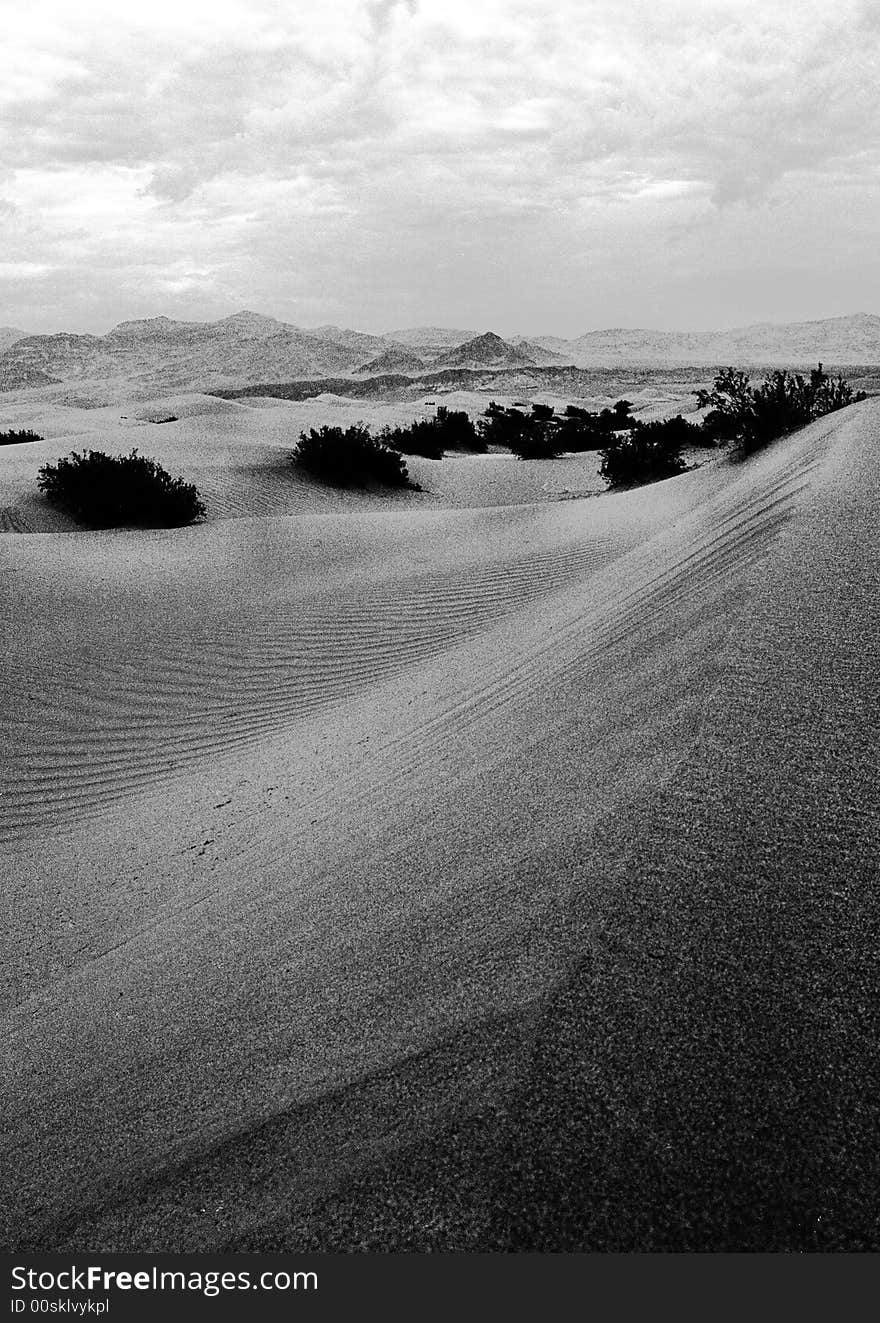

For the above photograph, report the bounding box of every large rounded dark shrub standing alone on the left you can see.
[37,450,205,528]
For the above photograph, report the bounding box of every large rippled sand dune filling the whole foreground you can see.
[0,404,880,1249]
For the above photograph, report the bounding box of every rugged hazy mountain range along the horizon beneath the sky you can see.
[0,312,880,394]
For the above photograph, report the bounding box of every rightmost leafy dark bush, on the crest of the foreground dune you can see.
[696,364,865,454]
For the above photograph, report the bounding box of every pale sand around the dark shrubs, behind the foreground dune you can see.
[0,393,624,532]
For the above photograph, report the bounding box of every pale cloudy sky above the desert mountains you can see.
[0,0,880,336]
